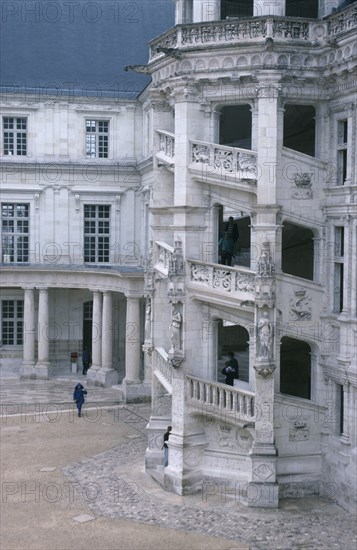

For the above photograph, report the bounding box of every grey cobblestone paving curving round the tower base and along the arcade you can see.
[1,380,357,550]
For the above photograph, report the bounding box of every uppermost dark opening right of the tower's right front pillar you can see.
[283,104,315,157]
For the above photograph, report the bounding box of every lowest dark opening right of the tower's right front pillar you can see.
[280,336,311,399]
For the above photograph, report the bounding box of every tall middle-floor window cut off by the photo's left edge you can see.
[1,203,29,263]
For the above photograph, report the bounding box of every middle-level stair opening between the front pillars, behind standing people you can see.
[218,206,251,267]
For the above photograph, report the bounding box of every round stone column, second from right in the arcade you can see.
[96,291,118,387]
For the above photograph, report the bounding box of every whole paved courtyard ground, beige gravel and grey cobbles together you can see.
[0,376,357,550]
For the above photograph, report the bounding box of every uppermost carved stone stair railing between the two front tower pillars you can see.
[190,141,257,180]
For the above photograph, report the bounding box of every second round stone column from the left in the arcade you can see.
[35,288,51,380]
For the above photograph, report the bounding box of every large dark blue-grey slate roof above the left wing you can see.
[0,0,174,97]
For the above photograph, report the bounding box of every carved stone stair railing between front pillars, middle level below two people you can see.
[188,260,255,300]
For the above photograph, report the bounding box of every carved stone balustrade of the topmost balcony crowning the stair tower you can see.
[150,16,330,61]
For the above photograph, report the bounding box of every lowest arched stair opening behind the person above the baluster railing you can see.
[217,320,249,383]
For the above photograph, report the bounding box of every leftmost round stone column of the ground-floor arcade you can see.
[20,288,36,378]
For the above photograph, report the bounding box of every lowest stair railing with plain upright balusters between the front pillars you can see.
[186,375,255,422]
